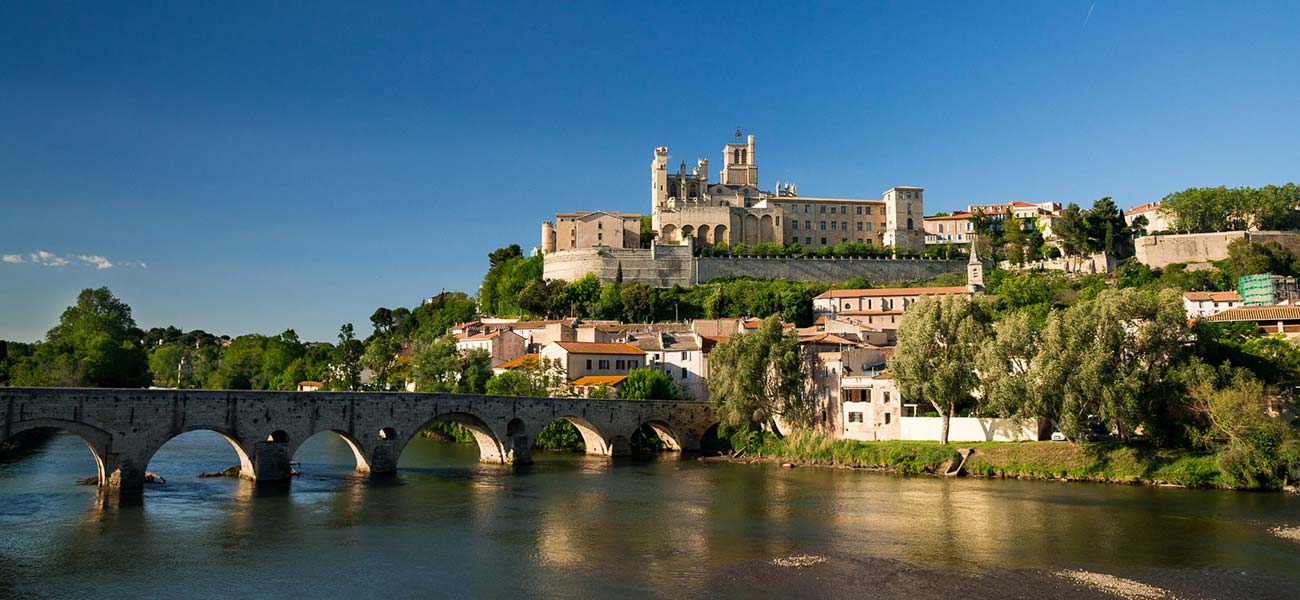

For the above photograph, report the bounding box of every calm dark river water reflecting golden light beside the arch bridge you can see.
[0,431,1300,599]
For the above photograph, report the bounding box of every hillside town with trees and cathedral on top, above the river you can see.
[0,135,1300,488]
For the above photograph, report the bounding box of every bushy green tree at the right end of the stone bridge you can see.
[709,316,811,431]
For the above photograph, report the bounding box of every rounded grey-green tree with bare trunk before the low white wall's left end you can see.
[889,296,992,444]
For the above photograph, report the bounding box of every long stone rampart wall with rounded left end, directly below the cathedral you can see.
[543,245,966,287]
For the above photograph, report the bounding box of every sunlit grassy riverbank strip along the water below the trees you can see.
[750,432,1253,487]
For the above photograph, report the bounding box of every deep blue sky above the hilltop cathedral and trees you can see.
[0,0,1300,340]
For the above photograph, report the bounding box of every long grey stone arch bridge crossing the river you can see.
[0,387,716,492]
